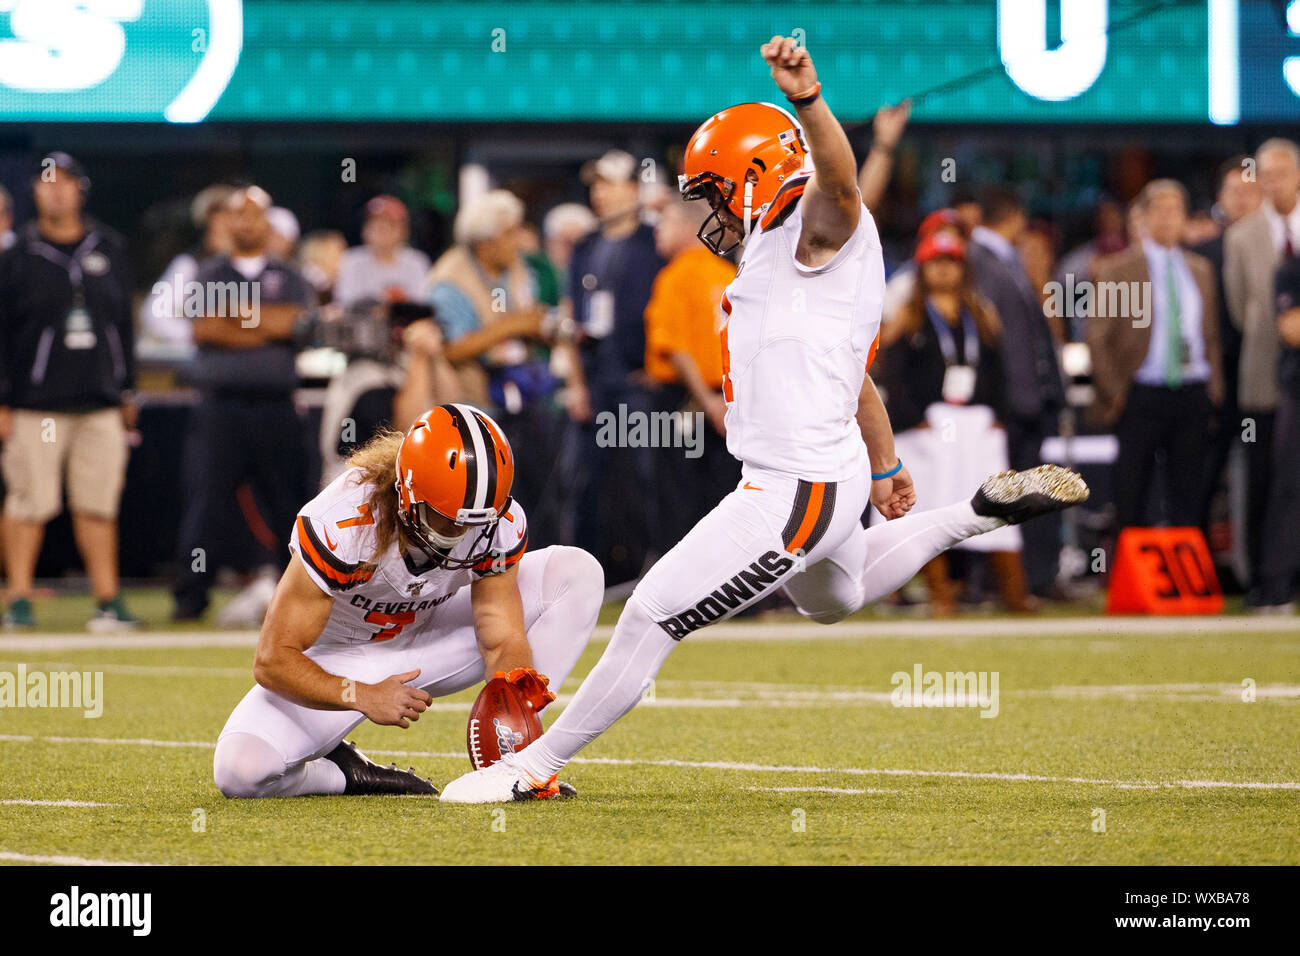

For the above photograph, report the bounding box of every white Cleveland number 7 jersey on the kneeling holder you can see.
[289,468,528,644]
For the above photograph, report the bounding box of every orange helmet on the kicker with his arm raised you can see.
[677,103,809,255]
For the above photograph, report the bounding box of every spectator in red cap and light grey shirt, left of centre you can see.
[334,196,429,308]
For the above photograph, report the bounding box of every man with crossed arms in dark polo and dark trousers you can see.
[173,186,313,620]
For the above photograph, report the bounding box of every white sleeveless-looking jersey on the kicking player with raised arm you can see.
[722,179,885,481]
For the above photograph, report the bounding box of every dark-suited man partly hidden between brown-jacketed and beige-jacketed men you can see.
[1192,156,1264,537]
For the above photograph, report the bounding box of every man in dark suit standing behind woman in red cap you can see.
[969,189,1065,597]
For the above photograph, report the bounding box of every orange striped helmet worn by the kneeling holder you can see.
[395,403,515,570]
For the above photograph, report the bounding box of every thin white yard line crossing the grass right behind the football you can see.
[0,734,1300,790]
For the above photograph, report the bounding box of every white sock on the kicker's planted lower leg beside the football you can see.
[514,593,677,782]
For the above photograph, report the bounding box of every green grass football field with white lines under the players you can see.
[0,613,1300,865]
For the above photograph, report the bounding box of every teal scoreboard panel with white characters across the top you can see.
[0,0,1300,125]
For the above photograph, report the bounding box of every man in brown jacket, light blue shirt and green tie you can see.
[1088,179,1223,533]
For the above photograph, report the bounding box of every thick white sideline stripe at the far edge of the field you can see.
[0,615,1300,650]
